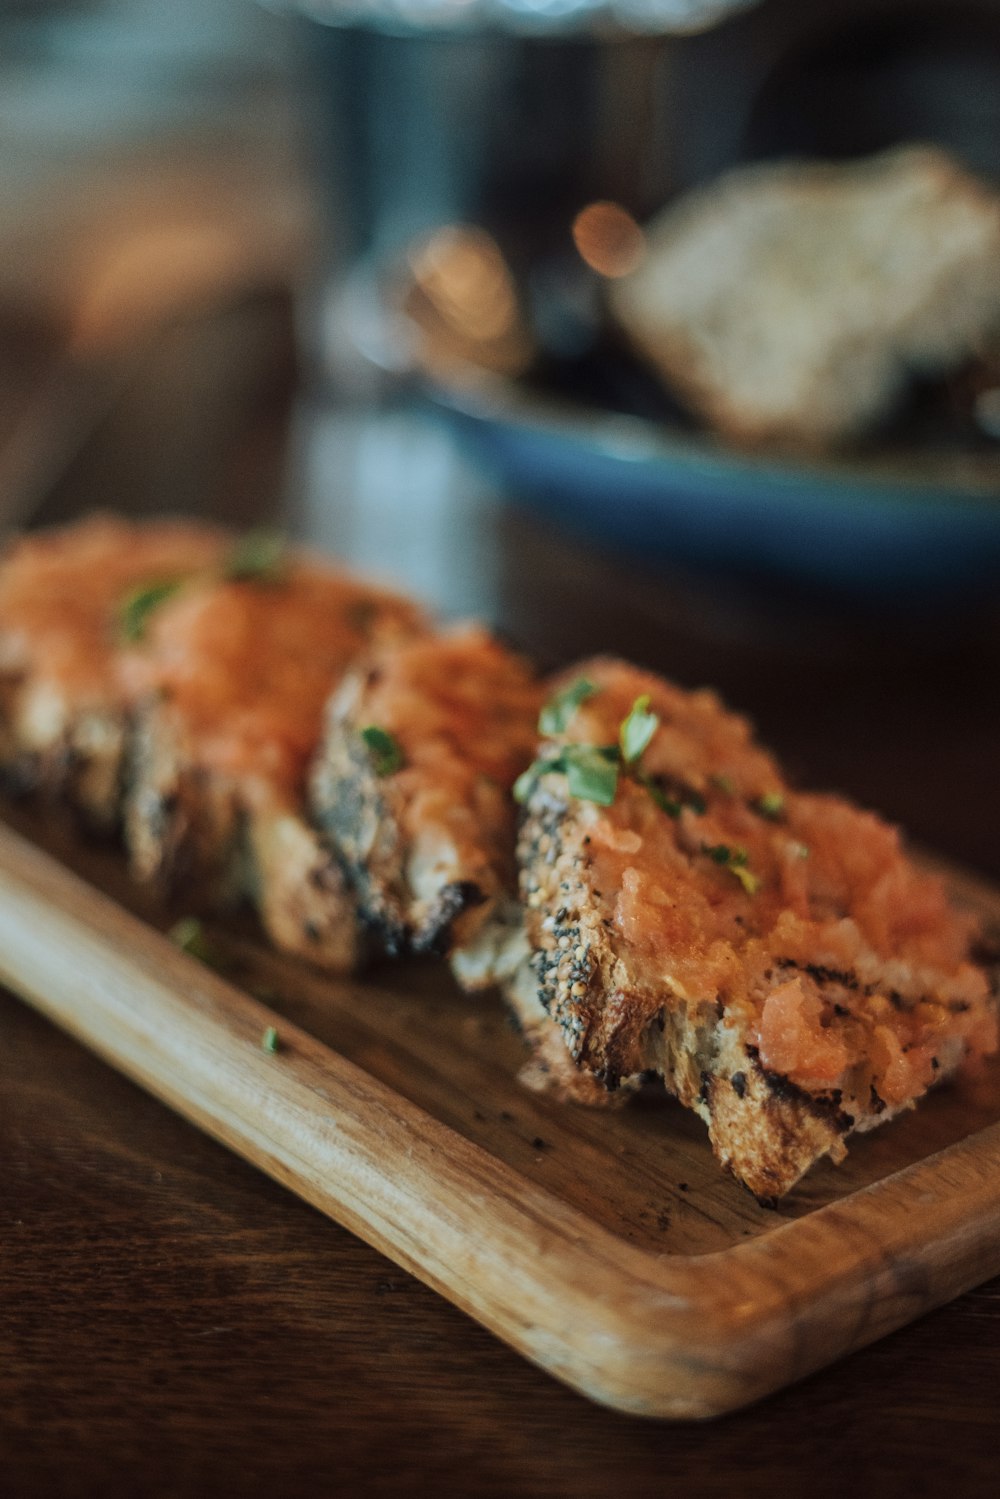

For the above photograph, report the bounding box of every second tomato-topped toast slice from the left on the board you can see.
[123,555,424,971]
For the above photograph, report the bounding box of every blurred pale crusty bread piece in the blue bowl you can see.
[610,147,1000,447]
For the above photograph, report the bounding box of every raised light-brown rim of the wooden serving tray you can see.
[0,827,1000,1418]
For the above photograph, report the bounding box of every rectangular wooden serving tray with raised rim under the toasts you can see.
[0,808,1000,1417]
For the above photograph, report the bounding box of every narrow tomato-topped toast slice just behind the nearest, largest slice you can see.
[310,627,541,965]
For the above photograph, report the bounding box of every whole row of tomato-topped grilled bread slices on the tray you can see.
[0,517,997,1201]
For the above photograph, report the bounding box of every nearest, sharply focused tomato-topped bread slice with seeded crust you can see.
[519,660,997,1201]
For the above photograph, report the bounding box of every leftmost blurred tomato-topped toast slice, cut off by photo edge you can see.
[0,516,231,830]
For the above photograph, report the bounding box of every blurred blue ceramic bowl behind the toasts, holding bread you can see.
[429,381,1000,603]
